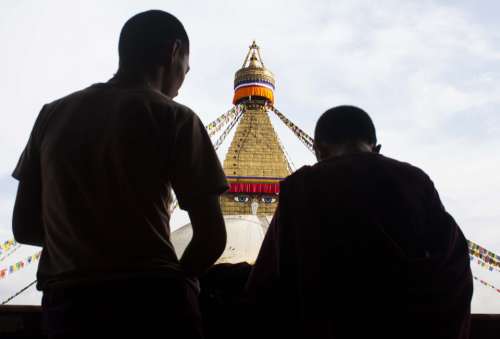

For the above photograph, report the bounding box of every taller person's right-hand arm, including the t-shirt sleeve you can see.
[170,111,228,277]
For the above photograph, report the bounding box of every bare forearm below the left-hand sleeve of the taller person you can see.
[12,175,44,246]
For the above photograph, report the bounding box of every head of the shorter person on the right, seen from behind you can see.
[314,106,381,161]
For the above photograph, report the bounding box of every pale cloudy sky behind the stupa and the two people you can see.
[0,0,500,313]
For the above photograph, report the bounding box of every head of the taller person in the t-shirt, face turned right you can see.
[118,10,189,98]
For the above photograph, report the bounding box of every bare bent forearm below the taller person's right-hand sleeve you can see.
[180,195,226,277]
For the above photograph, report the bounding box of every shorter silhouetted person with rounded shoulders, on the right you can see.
[247,106,472,339]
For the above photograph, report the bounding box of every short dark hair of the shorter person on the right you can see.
[314,106,377,145]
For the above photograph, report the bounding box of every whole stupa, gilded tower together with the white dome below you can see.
[171,42,296,263]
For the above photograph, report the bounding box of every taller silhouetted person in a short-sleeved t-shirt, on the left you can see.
[13,10,227,338]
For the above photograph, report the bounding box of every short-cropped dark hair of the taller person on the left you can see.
[118,10,189,69]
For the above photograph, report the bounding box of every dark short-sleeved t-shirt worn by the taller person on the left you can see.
[13,82,228,289]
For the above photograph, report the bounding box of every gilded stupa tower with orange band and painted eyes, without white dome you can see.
[221,42,291,216]
